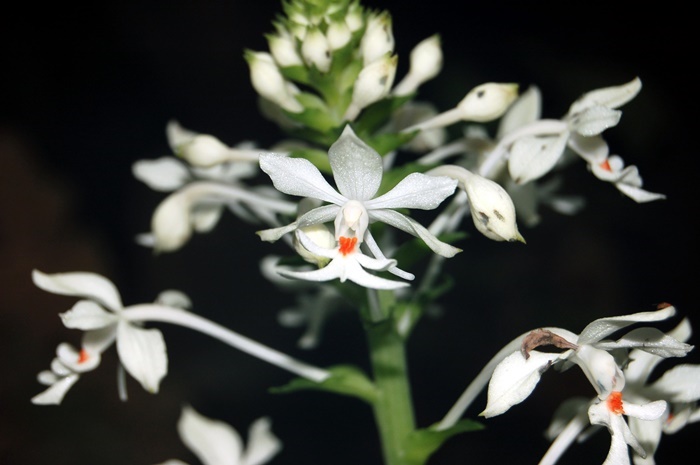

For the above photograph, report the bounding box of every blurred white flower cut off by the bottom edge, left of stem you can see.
[160,406,282,465]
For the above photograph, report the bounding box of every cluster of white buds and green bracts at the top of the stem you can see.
[245,0,413,153]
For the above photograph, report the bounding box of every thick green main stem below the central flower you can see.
[367,318,415,465]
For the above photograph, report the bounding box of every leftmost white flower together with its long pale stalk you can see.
[32,270,330,404]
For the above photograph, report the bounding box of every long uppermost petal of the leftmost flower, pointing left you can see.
[32,270,122,311]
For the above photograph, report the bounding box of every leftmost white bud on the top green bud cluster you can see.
[245,51,304,113]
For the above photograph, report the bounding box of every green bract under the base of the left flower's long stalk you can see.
[270,365,377,404]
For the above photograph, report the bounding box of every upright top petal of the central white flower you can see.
[328,125,383,203]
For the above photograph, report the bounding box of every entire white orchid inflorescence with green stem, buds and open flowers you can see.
[32,0,700,465]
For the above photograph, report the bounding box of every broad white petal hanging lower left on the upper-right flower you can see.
[508,131,569,184]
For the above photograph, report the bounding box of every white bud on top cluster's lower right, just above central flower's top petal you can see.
[345,54,398,121]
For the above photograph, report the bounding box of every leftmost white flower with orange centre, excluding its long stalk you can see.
[32,270,168,404]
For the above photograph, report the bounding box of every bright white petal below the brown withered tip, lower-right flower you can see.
[480,350,559,418]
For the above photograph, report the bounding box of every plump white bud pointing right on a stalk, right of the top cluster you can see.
[457,82,518,123]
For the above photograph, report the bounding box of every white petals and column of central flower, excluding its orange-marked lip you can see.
[257,126,460,258]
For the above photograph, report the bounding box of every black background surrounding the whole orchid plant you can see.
[0,1,700,465]
